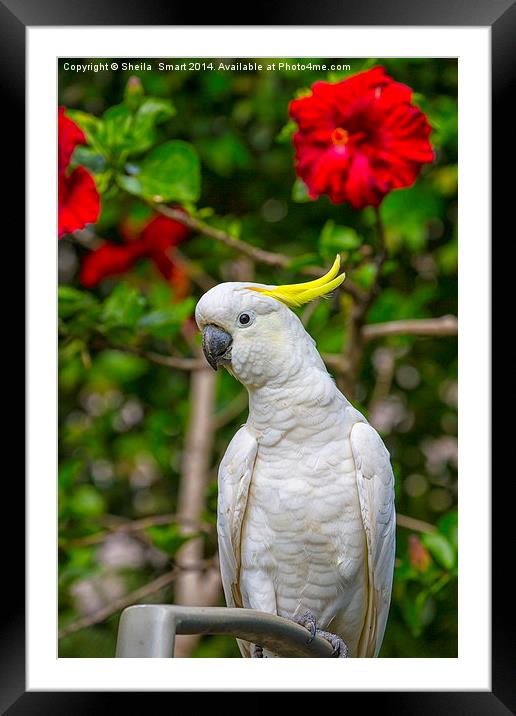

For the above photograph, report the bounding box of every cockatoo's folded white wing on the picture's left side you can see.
[217,425,258,656]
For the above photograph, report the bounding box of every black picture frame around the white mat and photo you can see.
[6,0,508,716]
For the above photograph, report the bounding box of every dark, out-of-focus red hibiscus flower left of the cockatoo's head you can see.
[81,215,190,298]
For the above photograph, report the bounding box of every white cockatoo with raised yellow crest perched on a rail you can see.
[195,257,395,657]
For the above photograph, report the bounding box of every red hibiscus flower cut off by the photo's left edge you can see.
[57,107,100,238]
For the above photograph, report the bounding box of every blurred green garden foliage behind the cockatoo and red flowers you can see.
[59,59,457,657]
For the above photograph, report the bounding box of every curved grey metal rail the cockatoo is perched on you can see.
[116,604,333,659]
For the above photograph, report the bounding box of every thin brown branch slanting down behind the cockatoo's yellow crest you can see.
[151,203,366,301]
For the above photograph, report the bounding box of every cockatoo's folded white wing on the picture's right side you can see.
[350,422,396,657]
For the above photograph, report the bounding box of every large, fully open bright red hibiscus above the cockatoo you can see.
[289,67,434,209]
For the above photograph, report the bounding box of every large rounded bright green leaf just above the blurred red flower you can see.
[117,140,201,202]
